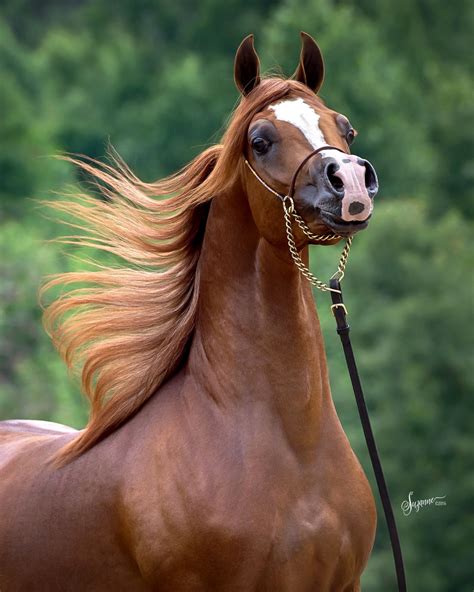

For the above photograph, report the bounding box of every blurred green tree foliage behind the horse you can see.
[0,0,474,592]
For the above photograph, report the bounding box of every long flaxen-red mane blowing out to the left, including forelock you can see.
[42,78,315,464]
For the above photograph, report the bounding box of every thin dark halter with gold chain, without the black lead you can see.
[244,145,353,292]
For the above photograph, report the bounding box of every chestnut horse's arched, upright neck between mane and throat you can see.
[188,183,330,446]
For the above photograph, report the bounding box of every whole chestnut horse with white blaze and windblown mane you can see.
[0,33,377,592]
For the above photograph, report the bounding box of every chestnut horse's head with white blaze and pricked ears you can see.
[234,33,378,247]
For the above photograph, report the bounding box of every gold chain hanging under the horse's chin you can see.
[283,196,353,292]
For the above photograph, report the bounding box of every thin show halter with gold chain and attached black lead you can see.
[244,145,407,592]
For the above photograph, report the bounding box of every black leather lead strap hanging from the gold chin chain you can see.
[329,279,407,592]
